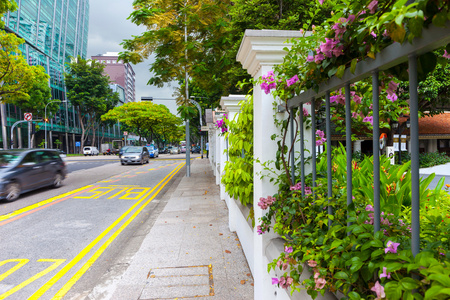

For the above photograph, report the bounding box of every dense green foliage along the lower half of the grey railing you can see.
[260,148,450,299]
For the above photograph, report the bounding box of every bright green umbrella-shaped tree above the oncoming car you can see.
[101,102,181,144]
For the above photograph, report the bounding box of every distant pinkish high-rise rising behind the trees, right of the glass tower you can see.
[91,52,136,102]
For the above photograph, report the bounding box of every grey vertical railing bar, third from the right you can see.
[345,83,353,226]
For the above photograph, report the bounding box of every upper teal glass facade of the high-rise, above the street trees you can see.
[3,0,89,99]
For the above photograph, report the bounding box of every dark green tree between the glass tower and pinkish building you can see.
[64,56,119,148]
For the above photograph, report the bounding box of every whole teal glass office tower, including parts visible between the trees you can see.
[3,0,119,153]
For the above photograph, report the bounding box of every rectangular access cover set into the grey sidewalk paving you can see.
[140,265,214,300]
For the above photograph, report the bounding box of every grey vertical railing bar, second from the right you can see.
[372,71,381,234]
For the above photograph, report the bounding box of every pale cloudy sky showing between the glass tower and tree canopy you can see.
[87,0,176,113]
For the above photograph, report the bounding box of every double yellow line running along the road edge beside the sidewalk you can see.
[28,163,185,300]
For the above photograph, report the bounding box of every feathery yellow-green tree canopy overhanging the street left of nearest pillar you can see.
[120,0,231,98]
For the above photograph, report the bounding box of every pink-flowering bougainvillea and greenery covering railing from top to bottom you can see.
[253,0,450,299]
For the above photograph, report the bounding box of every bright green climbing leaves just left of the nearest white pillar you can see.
[222,95,253,206]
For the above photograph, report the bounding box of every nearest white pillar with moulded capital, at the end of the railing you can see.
[237,30,302,299]
